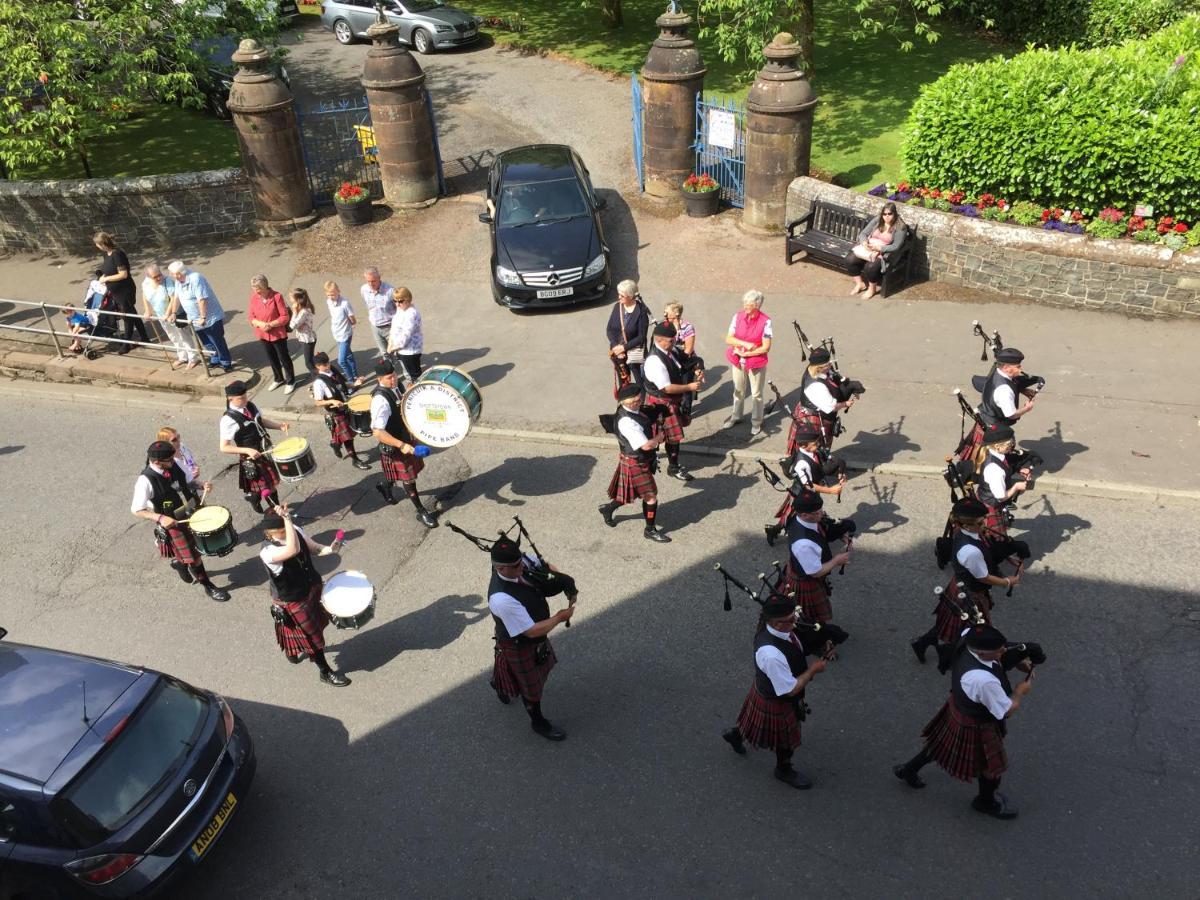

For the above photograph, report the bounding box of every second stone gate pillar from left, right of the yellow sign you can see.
[362,7,438,208]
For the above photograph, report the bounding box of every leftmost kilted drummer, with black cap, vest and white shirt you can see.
[130,440,229,602]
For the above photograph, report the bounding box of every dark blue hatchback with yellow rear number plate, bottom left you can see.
[0,629,256,900]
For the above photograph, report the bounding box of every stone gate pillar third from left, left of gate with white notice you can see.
[642,4,708,199]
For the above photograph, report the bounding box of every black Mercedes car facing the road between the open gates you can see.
[479,144,611,310]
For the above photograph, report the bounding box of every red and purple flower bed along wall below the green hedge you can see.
[868,181,1200,251]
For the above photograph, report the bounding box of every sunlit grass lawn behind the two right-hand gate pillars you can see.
[458,0,1004,187]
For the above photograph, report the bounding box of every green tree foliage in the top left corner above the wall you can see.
[0,0,277,173]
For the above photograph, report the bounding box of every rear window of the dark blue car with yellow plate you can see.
[54,679,209,846]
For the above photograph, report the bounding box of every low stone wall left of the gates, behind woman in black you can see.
[0,168,256,253]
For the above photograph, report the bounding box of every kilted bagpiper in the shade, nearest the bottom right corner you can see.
[892,625,1045,818]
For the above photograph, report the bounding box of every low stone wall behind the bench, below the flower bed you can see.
[787,178,1200,318]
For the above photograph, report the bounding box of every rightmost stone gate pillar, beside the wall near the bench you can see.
[742,31,817,230]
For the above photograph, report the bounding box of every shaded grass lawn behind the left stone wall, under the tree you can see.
[13,103,241,180]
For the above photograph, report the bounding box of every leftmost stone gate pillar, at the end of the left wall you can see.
[229,38,317,232]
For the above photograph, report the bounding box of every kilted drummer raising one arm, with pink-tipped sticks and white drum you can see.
[258,506,350,688]
